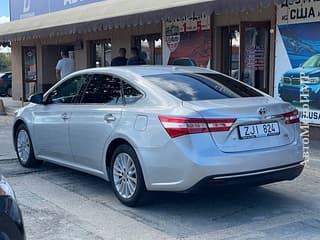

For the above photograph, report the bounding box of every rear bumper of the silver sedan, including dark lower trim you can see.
[136,131,303,192]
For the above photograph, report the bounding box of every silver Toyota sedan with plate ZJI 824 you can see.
[13,66,304,206]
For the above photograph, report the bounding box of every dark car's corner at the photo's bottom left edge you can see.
[0,175,25,240]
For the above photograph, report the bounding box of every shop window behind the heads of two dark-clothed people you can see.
[129,33,162,65]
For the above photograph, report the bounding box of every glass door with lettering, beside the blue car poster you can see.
[240,22,270,93]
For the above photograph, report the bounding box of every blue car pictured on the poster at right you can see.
[278,54,320,109]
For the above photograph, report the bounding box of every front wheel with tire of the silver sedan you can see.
[14,124,42,168]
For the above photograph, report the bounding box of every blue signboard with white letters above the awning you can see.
[10,0,106,21]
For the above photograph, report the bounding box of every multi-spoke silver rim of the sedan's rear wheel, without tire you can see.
[113,153,137,199]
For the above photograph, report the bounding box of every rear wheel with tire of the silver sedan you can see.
[109,144,147,207]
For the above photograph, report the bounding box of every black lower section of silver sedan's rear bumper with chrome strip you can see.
[184,161,305,192]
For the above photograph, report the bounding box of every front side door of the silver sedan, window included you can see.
[33,75,88,163]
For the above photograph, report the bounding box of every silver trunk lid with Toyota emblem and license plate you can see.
[183,97,297,152]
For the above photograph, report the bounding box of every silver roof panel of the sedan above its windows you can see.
[74,65,218,77]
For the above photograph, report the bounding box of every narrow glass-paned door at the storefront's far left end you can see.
[22,47,37,100]
